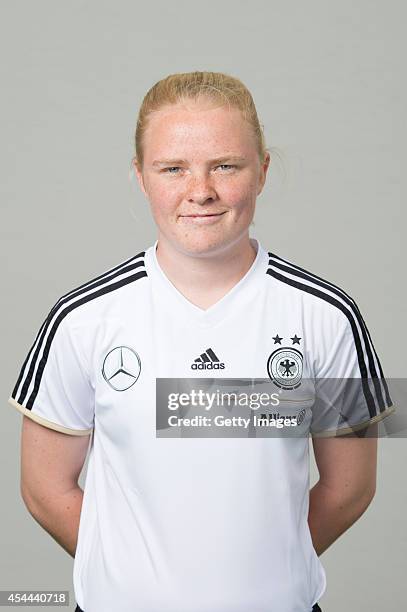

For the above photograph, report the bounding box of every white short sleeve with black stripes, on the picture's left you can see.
[8,307,94,436]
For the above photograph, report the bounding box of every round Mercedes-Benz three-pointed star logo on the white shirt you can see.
[102,346,141,391]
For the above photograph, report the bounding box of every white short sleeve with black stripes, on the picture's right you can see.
[310,307,395,437]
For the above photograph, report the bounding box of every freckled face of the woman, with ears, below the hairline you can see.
[135,101,270,256]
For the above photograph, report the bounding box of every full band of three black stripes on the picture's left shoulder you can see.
[12,251,147,410]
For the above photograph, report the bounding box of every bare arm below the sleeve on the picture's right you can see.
[308,424,377,555]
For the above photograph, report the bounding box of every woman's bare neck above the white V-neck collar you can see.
[156,233,256,309]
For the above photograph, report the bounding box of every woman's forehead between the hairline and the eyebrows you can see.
[144,101,255,156]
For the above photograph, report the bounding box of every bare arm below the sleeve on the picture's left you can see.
[21,416,90,557]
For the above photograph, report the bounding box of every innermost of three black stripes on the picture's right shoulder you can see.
[267,268,387,417]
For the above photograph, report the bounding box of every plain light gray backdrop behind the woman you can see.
[0,0,407,612]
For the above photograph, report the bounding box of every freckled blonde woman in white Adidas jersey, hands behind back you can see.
[10,72,393,612]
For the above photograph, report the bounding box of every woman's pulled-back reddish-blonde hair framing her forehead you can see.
[133,72,268,168]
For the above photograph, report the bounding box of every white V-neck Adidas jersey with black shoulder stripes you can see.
[9,238,394,612]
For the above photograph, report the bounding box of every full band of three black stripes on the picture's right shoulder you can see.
[267,253,392,416]
